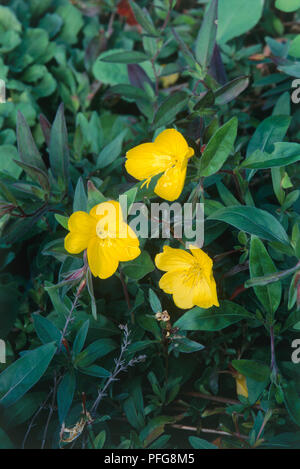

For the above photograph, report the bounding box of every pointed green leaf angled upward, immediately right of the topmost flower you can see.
[200,117,238,176]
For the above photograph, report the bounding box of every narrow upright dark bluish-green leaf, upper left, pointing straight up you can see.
[49,104,69,190]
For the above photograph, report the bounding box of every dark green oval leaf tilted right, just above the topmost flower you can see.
[153,91,188,129]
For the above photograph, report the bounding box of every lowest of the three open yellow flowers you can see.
[155,245,219,309]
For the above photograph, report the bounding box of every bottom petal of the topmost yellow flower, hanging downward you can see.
[154,159,187,202]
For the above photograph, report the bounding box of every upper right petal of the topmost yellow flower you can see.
[154,129,194,158]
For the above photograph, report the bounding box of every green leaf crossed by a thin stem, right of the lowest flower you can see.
[249,237,282,314]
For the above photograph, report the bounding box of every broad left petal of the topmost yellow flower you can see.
[125,143,172,181]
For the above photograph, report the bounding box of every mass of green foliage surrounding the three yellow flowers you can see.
[0,0,300,450]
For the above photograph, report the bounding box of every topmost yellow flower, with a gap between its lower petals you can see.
[125,129,194,201]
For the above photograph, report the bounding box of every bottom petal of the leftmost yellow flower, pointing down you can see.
[87,237,119,279]
